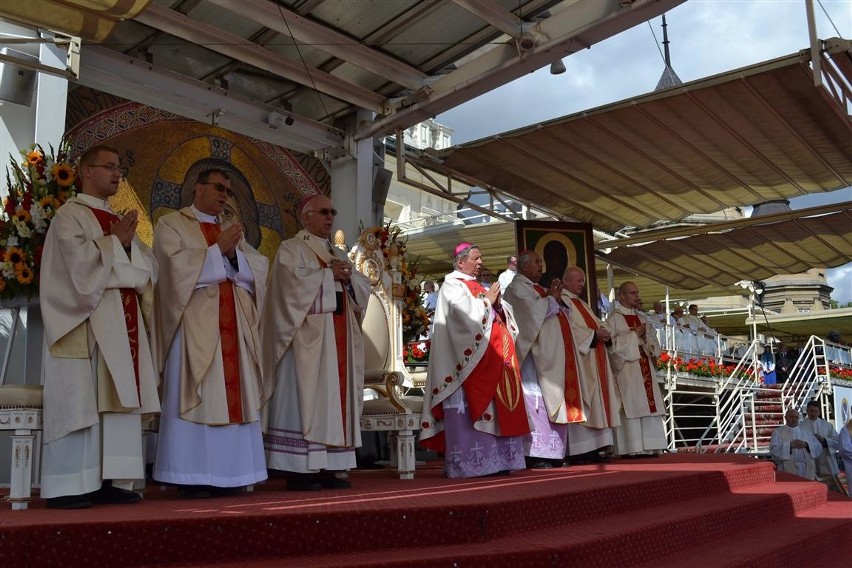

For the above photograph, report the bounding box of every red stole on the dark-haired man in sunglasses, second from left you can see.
[200,223,243,424]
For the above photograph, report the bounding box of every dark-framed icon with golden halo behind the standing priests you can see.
[515,221,598,312]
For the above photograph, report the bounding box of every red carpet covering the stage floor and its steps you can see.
[0,454,852,568]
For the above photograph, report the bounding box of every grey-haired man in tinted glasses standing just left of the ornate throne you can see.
[262,195,370,491]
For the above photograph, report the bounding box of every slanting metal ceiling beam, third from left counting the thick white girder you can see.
[207,0,429,89]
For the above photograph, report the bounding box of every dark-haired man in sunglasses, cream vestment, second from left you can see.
[154,169,269,498]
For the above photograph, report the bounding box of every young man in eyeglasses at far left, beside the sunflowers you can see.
[40,146,160,509]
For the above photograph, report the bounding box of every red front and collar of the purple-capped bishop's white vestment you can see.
[462,280,530,436]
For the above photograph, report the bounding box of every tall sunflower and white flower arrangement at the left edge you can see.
[0,145,77,299]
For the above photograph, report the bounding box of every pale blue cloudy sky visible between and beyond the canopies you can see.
[436,0,852,304]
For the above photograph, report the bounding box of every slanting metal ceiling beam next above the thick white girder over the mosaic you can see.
[134,0,387,113]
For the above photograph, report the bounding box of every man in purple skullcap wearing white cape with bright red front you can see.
[420,243,531,478]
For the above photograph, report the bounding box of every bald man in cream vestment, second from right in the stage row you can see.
[562,266,621,463]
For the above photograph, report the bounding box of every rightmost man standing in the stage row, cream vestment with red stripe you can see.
[606,282,668,457]
